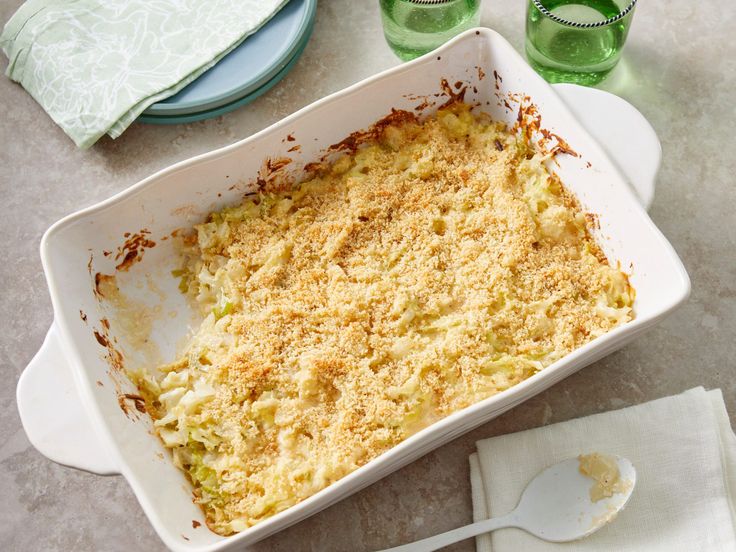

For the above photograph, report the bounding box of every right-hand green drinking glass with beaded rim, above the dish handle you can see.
[526,0,636,86]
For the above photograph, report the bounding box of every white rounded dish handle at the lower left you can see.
[16,324,120,475]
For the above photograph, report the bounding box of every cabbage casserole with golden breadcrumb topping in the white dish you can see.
[135,103,634,534]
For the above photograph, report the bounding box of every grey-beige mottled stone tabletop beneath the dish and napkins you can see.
[0,0,736,551]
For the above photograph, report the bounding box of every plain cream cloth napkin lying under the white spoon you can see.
[470,387,736,552]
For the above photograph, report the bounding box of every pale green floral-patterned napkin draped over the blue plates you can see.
[0,0,286,148]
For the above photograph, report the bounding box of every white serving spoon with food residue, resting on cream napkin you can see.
[384,456,636,552]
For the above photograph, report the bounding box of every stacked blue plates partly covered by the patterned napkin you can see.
[138,0,317,125]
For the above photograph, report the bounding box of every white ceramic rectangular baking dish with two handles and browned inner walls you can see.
[18,29,690,551]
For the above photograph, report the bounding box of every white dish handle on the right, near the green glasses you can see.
[552,84,662,209]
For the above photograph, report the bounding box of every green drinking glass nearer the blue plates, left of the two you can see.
[381,0,480,61]
